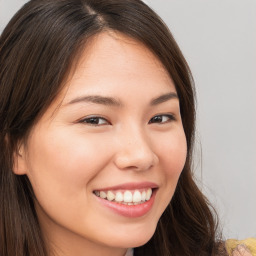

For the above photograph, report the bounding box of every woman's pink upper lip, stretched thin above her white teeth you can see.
[94,181,158,191]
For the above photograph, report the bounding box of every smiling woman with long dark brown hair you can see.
[0,0,254,256]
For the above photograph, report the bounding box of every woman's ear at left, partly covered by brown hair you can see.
[13,144,28,175]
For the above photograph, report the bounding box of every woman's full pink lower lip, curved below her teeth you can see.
[97,189,156,218]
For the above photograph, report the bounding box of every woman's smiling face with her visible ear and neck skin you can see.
[14,32,187,255]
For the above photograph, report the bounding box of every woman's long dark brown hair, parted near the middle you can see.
[0,0,220,256]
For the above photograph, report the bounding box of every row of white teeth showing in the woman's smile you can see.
[93,188,153,205]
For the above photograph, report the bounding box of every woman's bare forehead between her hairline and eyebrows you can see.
[61,31,175,103]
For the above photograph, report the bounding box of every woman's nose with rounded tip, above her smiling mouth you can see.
[115,130,159,171]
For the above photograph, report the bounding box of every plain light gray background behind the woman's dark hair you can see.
[0,0,256,239]
